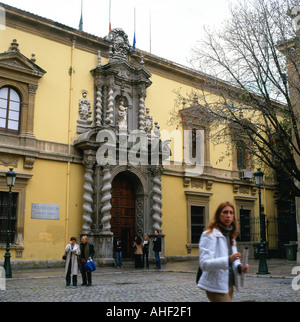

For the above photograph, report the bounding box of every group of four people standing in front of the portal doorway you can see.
[114,230,161,269]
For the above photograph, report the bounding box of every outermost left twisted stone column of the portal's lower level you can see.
[82,155,95,234]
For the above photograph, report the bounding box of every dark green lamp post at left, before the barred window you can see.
[4,168,16,278]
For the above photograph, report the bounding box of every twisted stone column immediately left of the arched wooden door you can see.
[101,167,112,235]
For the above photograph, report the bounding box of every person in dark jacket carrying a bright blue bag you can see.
[80,236,95,286]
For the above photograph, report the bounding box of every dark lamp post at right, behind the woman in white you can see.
[254,169,270,275]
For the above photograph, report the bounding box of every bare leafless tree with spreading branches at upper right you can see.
[172,0,300,195]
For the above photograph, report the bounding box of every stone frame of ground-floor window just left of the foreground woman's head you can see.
[184,190,213,254]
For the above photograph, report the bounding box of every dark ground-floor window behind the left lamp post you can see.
[0,192,18,244]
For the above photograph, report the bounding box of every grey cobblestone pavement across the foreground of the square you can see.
[0,262,300,302]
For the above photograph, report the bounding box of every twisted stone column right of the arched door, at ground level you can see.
[151,170,162,232]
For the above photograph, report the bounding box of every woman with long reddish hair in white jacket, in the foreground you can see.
[198,201,249,302]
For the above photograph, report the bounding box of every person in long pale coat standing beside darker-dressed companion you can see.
[65,237,80,286]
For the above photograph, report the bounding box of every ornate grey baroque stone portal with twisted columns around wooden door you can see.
[74,29,164,265]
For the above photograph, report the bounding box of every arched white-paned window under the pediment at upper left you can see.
[0,87,21,133]
